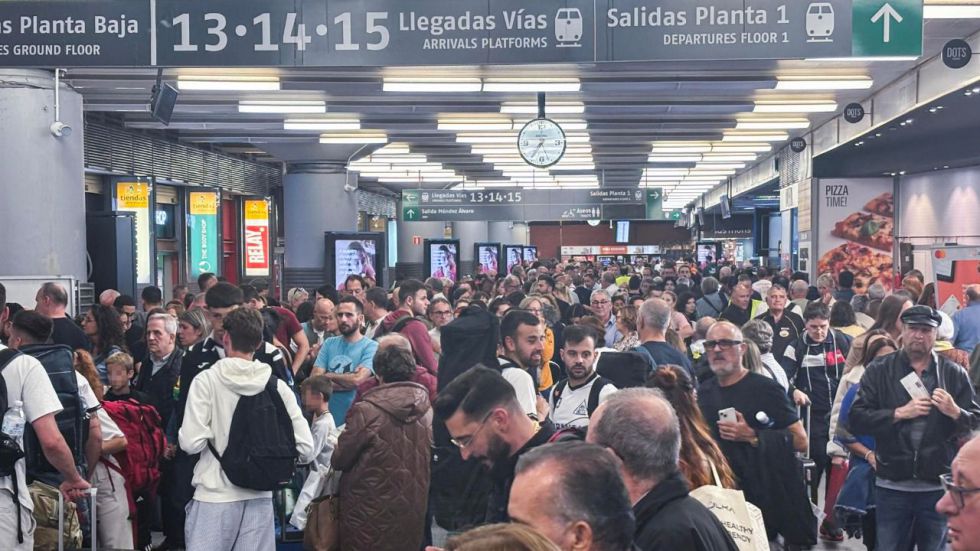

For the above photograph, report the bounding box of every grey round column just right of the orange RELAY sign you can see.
[283,164,357,289]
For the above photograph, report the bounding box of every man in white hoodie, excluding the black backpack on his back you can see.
[179,308,313,551]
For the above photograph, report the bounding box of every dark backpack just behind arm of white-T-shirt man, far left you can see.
[21,344,88,486]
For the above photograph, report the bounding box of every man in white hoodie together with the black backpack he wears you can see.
[179,308,313,549]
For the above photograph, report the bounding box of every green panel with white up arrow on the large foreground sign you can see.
[851,0,922,57]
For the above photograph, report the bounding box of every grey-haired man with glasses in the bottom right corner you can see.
[936,434,980,551]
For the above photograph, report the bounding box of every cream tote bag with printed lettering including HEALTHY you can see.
[690,460,769,551]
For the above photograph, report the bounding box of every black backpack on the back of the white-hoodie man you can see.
[208,375,299,491]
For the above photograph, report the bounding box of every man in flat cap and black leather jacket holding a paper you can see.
[850,306,980,549]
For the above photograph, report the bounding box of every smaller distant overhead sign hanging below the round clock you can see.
[401,188,669,222]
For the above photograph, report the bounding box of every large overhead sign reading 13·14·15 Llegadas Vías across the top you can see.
[0,0,923,67]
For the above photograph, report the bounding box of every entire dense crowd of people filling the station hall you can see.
[0,258,980,551]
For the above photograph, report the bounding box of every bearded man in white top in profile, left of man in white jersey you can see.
[497,310,545,419]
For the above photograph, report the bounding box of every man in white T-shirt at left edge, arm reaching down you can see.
[0,284,89,551]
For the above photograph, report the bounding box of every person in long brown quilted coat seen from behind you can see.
[330,344,432,551]
